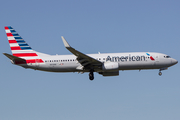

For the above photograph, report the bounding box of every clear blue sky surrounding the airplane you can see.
[0,0,180,120]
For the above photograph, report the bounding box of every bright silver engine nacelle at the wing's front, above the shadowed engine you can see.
[102,62,119,70]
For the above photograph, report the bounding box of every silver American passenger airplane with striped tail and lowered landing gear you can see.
[3,26,178,80]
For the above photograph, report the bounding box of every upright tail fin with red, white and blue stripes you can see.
[5,26,43,63]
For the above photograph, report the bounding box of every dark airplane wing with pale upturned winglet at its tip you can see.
[61,36,102,70]
